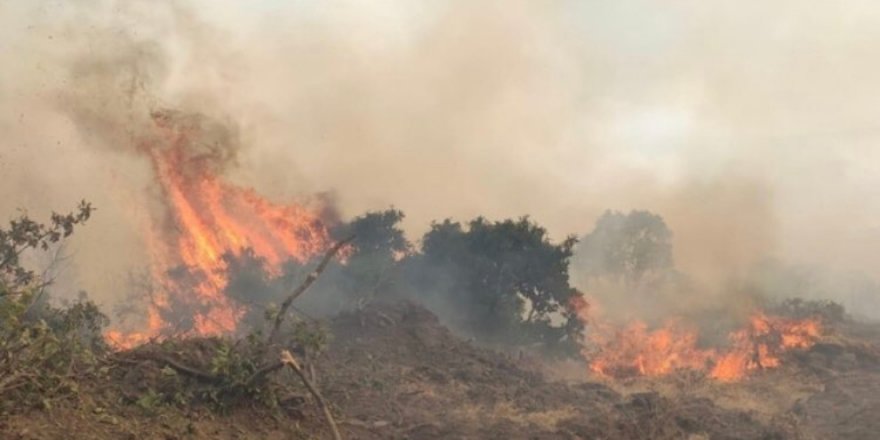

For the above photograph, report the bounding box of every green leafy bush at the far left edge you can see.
[0,202,107,412]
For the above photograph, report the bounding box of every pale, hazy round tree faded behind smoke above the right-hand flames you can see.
[575,211,674,284]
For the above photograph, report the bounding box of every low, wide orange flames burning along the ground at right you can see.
[571,298,821,381]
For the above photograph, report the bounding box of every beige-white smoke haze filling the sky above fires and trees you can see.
[0,0,880,315]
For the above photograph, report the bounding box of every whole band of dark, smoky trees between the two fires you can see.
[220,210,581,352]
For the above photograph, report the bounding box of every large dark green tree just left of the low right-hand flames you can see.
[410,217,578,352]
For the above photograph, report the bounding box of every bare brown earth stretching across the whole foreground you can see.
[0,302,880,440]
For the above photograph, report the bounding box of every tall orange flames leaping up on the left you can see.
[106,112,330,347]
